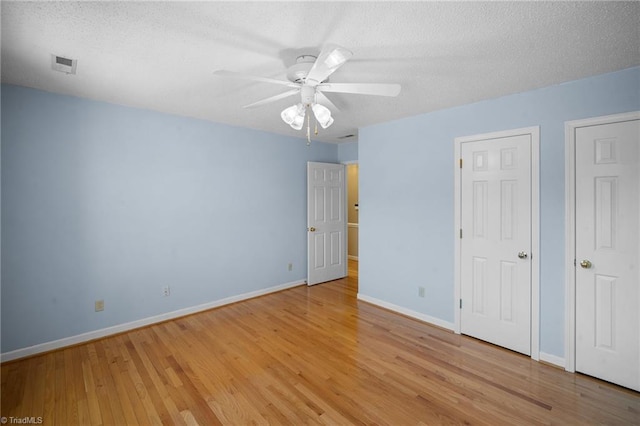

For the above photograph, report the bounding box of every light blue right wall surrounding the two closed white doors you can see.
[358,68,640,357]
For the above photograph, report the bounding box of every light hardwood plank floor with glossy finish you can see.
[0,262,640,426]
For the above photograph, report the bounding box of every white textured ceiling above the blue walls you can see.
[0,1,640,141]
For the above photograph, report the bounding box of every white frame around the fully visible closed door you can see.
[453,126,540,361]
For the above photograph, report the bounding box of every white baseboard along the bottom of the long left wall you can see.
[0,280,307,362]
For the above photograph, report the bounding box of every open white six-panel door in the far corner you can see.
[307,162,347,285]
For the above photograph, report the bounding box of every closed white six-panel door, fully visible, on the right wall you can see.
[460,134,537,355]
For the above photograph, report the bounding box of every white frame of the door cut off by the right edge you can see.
[564,111,640,373]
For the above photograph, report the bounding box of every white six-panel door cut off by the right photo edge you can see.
[575,120,640,390]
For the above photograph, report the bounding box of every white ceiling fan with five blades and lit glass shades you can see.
[214,44,400,141]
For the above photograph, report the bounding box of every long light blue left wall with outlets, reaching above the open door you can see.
[1,85,338,352]
